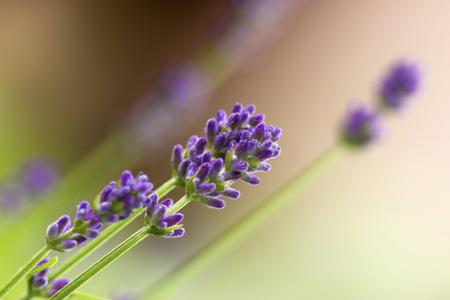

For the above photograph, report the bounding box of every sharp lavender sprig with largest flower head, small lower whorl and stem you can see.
[48,103,281,299]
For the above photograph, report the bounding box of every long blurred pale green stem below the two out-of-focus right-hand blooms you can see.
[142,144,345,300]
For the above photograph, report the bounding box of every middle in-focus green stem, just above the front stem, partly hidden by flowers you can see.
[50,178,175,280]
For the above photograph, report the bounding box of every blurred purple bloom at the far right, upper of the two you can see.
[378,61,420,110]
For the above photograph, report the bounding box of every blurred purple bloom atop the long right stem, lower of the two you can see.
[342,105,380,146]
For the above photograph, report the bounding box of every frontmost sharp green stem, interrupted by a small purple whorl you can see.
[50,196,190,300]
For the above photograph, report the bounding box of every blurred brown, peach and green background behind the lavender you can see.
[0,0,450,300]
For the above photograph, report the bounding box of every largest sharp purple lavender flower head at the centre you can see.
[172,103,281,209]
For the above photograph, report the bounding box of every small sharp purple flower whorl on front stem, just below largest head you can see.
[145,194,184,238]
